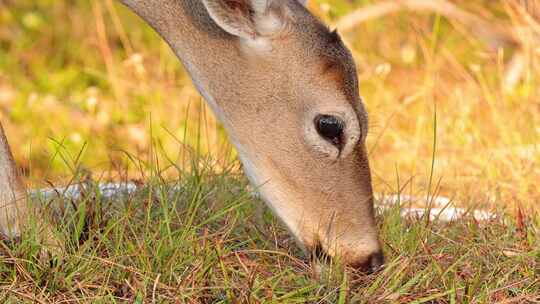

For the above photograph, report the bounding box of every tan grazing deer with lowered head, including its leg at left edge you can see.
[0,0,384,271]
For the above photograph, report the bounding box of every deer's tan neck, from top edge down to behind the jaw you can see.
[122,0,245,124]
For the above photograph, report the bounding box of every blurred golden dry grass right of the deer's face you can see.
[338,3,540,214]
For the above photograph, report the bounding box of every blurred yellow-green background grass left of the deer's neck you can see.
[0,1,227,182]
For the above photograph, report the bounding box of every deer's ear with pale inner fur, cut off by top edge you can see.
[202,0,284,39]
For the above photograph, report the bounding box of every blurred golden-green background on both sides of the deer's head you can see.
[0,0,540,210]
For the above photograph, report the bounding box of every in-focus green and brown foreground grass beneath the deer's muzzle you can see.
[0,161,540,303]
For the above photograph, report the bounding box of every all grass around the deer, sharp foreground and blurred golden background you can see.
[0,0,540,303]
